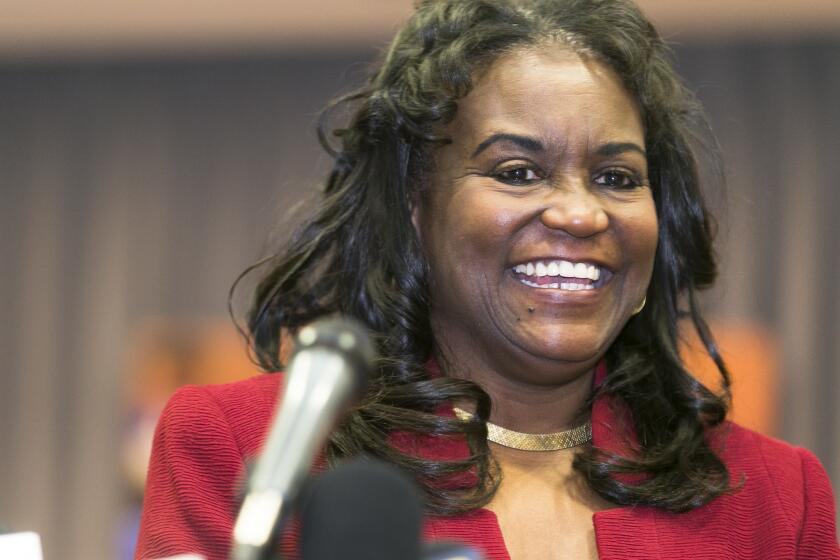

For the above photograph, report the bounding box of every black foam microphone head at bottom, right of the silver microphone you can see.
[300,459,423,560]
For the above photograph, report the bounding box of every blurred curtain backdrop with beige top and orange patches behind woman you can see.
[0,0,840,560]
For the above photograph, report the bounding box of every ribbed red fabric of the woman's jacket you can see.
[136,375,840,560]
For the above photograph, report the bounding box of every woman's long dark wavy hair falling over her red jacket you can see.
[236,0,729,514]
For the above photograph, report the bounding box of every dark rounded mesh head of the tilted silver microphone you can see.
[292,317,377,398]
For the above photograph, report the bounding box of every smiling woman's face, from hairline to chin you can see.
[413,47,658,384]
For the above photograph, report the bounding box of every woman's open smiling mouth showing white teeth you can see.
[511,259,612,292]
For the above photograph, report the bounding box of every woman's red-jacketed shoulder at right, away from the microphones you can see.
[641,423,840,560]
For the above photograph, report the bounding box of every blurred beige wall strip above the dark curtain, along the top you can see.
[0,0,840,59]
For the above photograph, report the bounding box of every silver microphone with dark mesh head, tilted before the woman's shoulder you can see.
[233,319,376,560]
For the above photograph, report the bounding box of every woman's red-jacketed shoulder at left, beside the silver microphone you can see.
[136,375,282,560]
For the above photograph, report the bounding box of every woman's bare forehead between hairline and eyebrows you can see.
[449,46,644,150]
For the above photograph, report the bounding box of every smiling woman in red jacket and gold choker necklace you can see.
[138,0,840,560]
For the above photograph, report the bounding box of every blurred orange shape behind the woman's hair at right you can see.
[680,321,779,436]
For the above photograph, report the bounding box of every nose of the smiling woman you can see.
[540,184,610,238]
